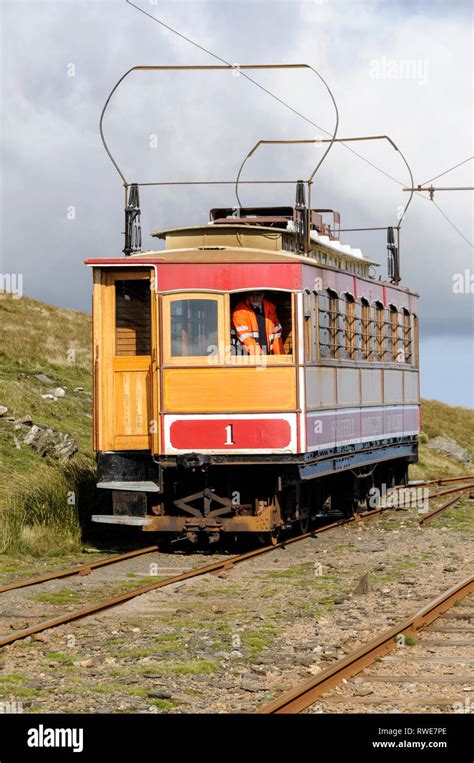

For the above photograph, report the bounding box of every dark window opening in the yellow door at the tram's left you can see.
[115,278,151,357]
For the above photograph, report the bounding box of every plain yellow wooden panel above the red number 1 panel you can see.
[163,368,296,413]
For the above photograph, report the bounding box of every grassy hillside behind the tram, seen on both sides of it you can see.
[0,294,474,553]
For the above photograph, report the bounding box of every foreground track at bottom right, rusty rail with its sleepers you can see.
[256,575,474,714]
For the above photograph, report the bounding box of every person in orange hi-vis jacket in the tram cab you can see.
[232,291,285,355]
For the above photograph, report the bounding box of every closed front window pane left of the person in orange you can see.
[170,299,218,357]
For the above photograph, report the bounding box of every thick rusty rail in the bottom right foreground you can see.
[255,575,474,714]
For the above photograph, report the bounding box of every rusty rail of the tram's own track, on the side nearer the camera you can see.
[0,508,387,647]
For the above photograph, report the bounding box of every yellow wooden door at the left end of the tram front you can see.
[94,269,160,453]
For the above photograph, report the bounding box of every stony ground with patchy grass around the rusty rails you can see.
[0,498,474,713]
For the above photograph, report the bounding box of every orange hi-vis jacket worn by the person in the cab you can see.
[232,299,285,355]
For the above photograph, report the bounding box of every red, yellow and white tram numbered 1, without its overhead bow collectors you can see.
[87,207,419,541]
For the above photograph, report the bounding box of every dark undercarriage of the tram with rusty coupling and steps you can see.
[92,440,417,544]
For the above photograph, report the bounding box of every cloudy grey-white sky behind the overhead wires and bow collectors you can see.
[0,0,474,406]
